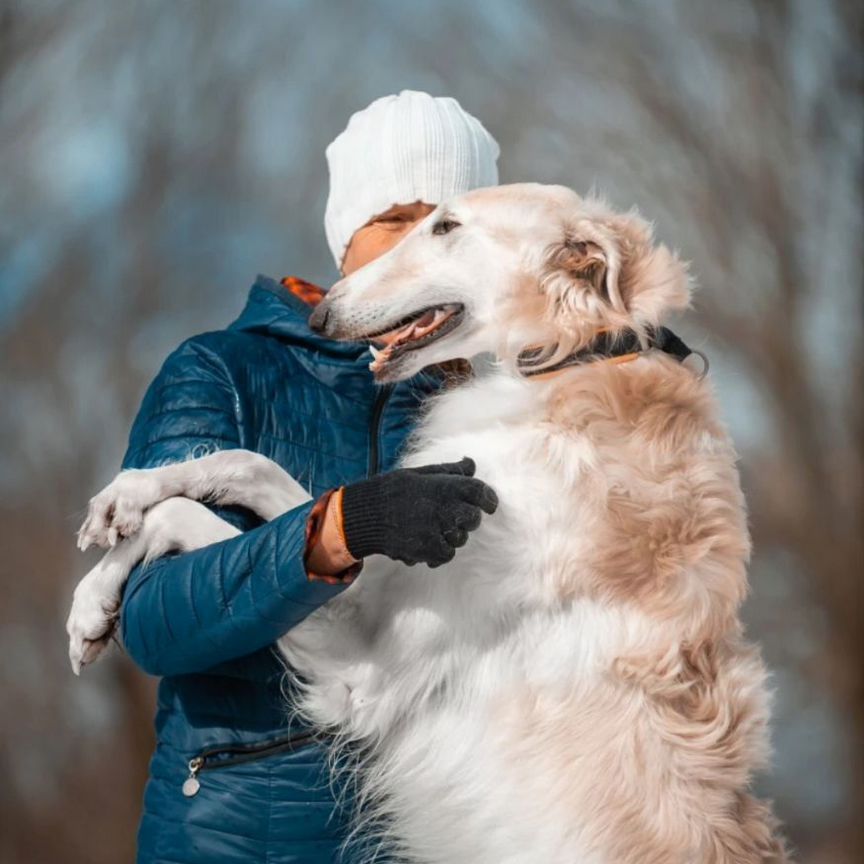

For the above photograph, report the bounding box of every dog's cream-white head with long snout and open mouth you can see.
[309,183,690,381]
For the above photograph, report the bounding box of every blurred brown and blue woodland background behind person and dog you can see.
[0,0,864,864]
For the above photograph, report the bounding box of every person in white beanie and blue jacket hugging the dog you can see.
[119,90,499,864]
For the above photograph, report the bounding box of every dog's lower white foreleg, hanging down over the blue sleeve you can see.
[66,498,240,675]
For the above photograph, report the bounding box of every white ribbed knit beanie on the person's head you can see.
[324,90,500,269]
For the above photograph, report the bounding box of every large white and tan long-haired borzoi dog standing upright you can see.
[69,184,786,864]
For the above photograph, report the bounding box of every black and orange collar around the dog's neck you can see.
[516,327,709,379]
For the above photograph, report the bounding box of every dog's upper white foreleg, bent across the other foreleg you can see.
[78,450,311,550]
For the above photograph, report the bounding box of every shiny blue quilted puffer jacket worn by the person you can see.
[120,277,444,864]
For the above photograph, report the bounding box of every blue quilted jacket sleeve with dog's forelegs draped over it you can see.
[120,334,347,675]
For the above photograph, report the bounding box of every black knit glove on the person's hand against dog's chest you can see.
[342,456,498,567]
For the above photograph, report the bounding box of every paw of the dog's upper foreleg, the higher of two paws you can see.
[78,468,165,552]
